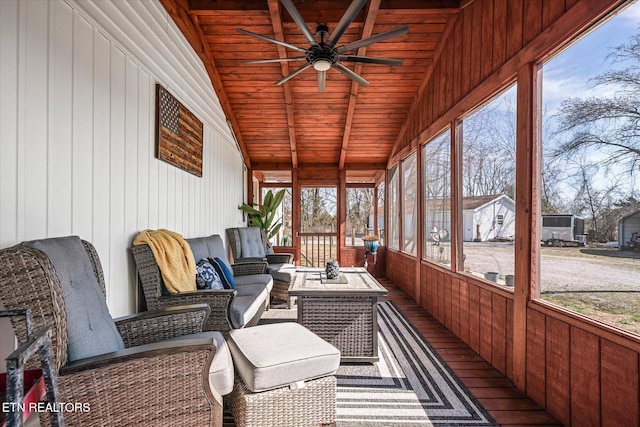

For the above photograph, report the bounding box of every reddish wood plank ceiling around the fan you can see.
[161,0,461,179]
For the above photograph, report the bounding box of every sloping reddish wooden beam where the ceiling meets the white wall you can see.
[160,0,251,168]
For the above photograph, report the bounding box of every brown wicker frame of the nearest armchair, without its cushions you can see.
[0,241,226,426]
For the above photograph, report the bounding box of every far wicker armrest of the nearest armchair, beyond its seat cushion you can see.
[115,304,211,347]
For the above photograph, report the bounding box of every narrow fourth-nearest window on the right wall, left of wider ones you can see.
[401,153,418,255]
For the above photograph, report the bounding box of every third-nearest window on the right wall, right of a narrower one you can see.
[422,129,451,265]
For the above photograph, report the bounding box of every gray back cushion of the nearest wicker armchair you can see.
[25,236,124,362]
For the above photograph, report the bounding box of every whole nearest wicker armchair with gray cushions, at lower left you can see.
[0,236,233,427]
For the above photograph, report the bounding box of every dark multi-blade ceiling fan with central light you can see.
[238,0,409,92]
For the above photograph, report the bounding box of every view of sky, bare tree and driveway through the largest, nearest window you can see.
[540,3,640,334]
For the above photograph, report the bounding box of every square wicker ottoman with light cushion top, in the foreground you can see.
[227,322,340,427]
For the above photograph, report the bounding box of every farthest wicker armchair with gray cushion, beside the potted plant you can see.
[227,227,296,308]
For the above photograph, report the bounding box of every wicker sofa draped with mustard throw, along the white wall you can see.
[131,234,273,333]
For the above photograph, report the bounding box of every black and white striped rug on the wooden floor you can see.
[336,301,497,427]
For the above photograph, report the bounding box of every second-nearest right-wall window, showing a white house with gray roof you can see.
[461,84,516,285]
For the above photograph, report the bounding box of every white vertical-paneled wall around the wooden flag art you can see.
[0,0,243,362]
